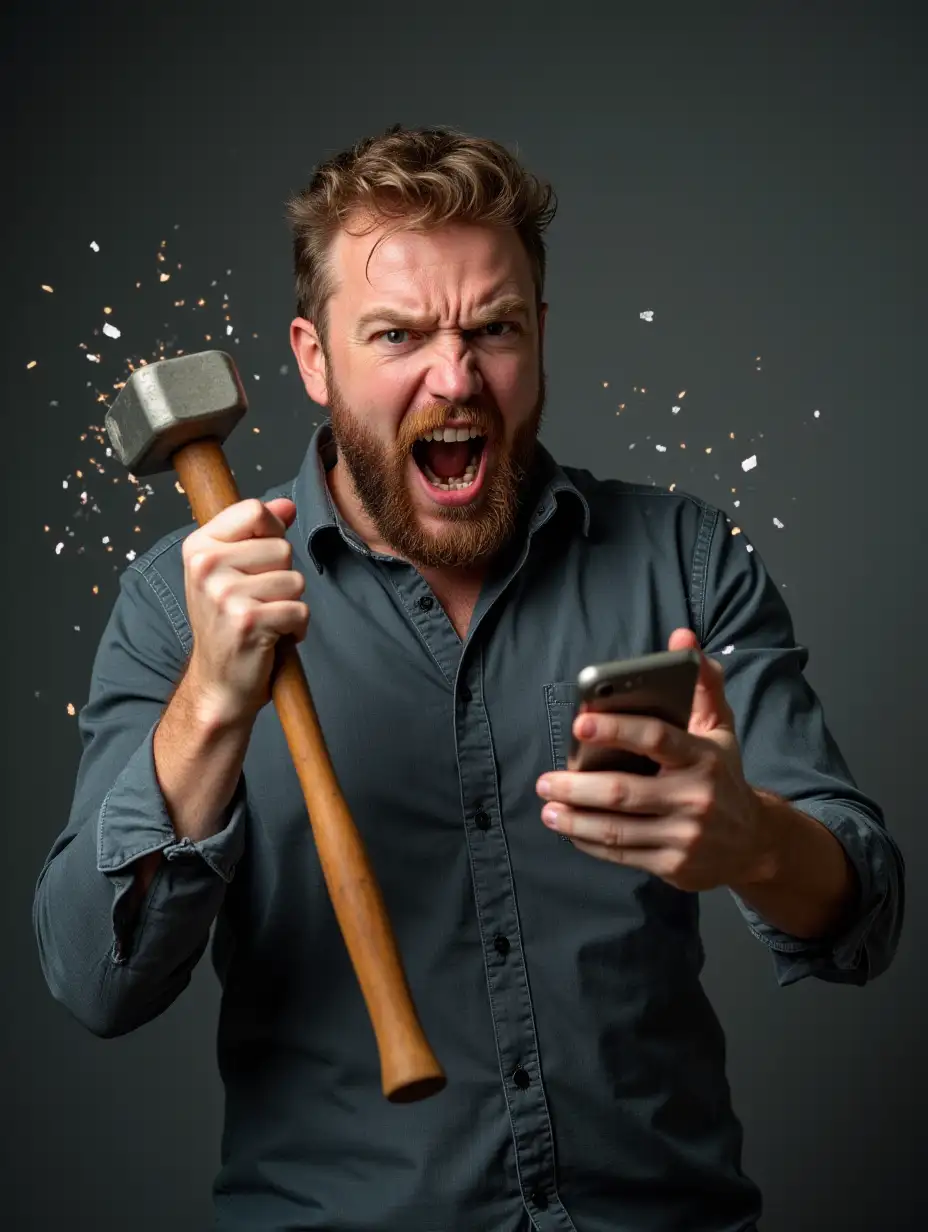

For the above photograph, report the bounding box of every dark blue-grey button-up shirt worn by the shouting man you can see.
[35,421,903,1232]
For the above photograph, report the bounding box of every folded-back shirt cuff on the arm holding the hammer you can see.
[96,723,246,882]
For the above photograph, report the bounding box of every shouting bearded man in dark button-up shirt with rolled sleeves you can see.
[30,128,903,1232]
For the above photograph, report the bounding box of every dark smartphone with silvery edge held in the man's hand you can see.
[567,650,699,775]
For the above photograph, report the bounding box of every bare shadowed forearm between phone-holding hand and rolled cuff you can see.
[731,788,858,940]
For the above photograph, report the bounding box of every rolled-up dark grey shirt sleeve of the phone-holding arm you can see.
[693,510,905,984]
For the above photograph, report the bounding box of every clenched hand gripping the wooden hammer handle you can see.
[184,498,309,724]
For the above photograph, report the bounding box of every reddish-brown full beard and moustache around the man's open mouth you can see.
[329,368,545,569]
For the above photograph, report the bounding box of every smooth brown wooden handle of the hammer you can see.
[171,439,445,1103]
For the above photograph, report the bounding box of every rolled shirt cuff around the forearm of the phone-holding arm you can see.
[731,801,890,986]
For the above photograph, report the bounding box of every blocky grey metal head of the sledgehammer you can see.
[104,351,248,474]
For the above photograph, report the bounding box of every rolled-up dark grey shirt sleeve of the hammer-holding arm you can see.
[33,548,246,1036]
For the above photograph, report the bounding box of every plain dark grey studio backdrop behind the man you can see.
[0,2,928,1232]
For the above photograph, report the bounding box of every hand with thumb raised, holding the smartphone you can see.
[536,628,773,891]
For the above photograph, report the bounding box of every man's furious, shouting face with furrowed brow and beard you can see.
[295,225,545,568]
